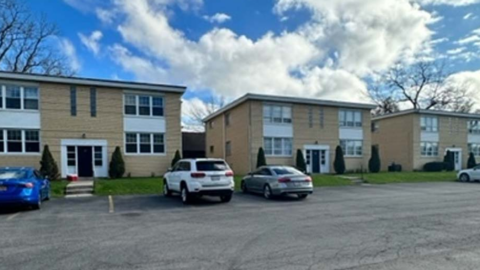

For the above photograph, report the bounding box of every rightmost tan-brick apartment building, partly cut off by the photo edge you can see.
[372,110,480,171]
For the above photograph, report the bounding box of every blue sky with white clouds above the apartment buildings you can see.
[27,0,480,127]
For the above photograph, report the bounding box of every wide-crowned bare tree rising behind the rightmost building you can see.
[369,61,473,114]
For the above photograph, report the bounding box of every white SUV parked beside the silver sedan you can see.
[163,159,235,204]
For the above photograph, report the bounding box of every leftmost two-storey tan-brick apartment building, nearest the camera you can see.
[0,72,185,177]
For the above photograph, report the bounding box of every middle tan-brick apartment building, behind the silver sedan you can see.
[204,94,375,175]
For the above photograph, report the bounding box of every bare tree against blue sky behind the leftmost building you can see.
[0,0,73,76]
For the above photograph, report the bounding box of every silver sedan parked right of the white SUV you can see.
[241,166,313,199]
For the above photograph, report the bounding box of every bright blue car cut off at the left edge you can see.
[0,167,50,209]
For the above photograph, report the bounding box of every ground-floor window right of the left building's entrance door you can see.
[125,133,165,154]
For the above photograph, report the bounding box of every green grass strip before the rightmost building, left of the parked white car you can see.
[354,172,456,184]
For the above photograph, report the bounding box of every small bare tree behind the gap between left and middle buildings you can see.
[183,95,225,131]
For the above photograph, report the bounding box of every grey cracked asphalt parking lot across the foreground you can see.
[0,183,480,270]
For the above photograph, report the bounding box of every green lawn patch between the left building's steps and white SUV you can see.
[95,177,163,196]
